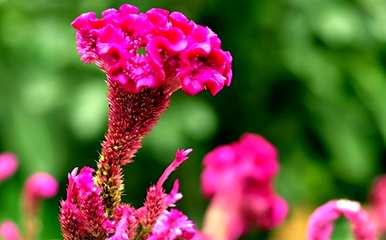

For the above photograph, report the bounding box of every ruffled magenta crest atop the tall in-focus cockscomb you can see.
[72,4,232,95]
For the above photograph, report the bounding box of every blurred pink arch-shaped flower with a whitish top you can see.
[307,200,376,240]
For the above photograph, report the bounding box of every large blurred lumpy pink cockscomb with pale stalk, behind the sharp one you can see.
[201,134,287,239]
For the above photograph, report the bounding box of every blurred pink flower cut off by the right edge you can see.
[369,176,386,236]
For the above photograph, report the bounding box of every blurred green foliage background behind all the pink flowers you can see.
[0,0,386,240]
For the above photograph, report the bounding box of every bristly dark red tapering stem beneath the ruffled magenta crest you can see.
[95,80,171,216]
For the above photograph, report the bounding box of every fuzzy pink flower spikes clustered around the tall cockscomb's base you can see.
[60,149,196,240]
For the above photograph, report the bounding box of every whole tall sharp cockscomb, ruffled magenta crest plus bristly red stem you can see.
[72,4,232,216]
